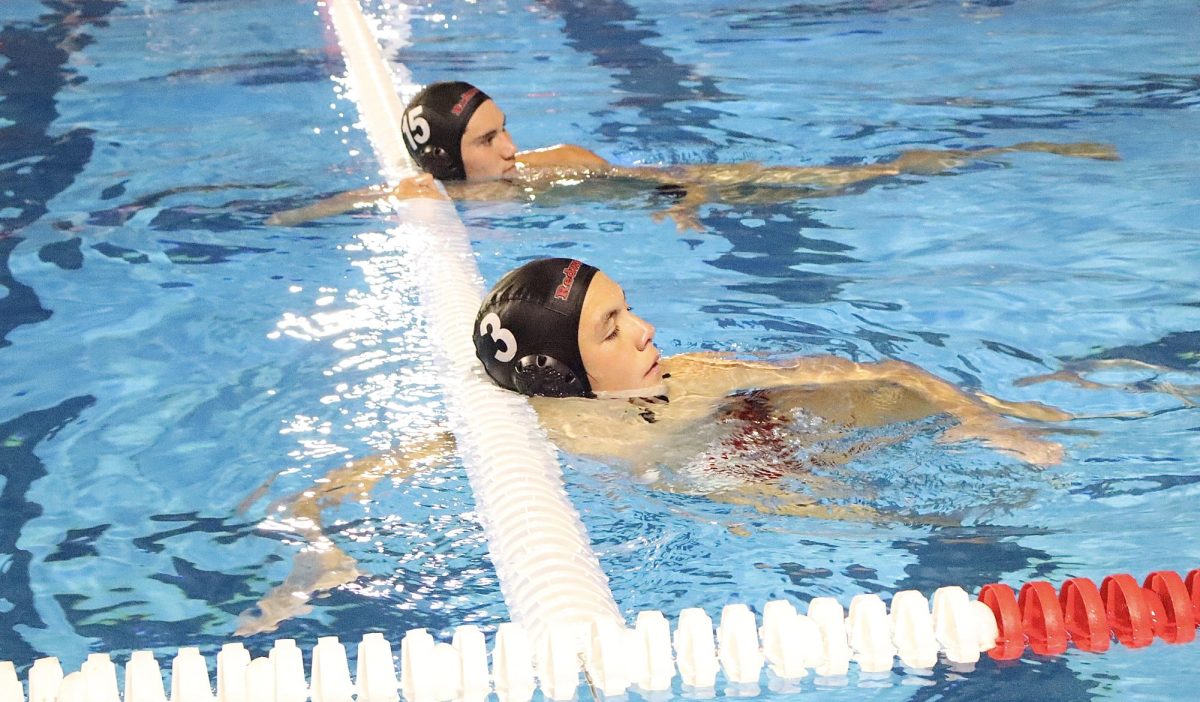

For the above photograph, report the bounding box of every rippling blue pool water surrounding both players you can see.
[0,0,1200,700]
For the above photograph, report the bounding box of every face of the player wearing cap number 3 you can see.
[578,272,662,392]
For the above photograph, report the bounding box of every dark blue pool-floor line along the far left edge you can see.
[0,0,121,661]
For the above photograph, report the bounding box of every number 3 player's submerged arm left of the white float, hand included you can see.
[235,433,455,636]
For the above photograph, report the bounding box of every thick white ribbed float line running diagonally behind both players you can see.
[326,0,620,652]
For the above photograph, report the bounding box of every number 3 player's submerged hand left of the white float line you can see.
[234,539,364,636]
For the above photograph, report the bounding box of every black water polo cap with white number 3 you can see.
[473,258,596,397]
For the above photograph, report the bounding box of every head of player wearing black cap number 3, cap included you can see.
[474,258,662,397]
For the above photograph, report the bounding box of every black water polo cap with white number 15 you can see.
[401,80,491,180]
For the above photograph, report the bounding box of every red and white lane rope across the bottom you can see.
[0,569,1200,702]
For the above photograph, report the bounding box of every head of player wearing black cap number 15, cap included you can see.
[401,82,516,180]
